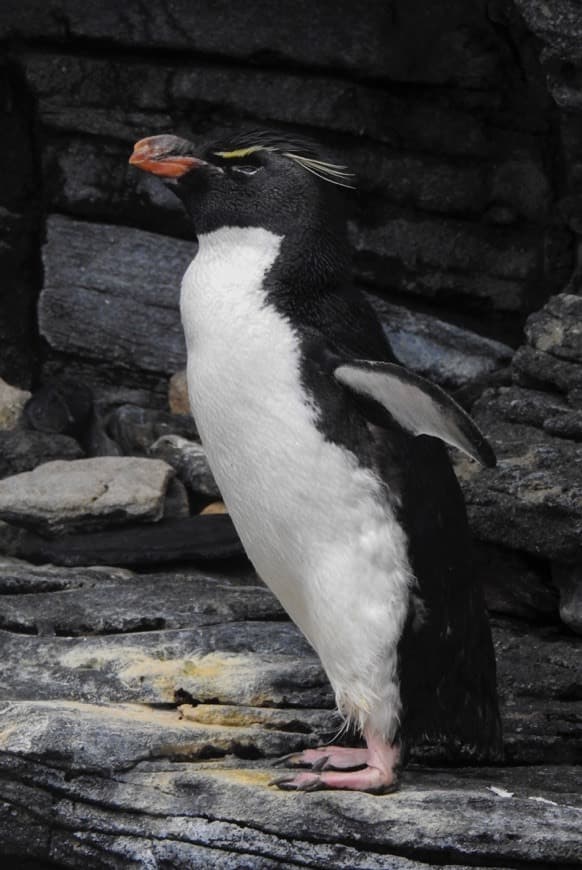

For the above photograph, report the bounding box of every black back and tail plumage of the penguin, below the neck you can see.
[274,287,501,761]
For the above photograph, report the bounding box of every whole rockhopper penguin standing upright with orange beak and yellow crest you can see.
[129,131,501,794]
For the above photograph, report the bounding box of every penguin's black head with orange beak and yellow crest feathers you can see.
[129,132,353,236]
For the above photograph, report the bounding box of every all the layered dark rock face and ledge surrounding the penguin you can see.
[0,0,582,870]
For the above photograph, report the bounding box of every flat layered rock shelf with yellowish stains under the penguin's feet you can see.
[0,559,582,870]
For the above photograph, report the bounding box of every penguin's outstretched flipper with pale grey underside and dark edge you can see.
[334,360,496,468]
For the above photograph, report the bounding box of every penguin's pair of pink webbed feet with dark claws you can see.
[271,733,399,794]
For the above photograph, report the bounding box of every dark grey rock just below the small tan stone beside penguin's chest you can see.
[106,405,198,464]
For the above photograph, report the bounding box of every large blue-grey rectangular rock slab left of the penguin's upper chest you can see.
[39,215,195,374]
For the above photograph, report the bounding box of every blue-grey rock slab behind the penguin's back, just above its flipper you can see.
[368,294,513,388]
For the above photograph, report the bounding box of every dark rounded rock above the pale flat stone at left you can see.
[25,378,93,438]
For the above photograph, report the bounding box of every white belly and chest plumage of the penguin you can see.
[181,228,410,744]
